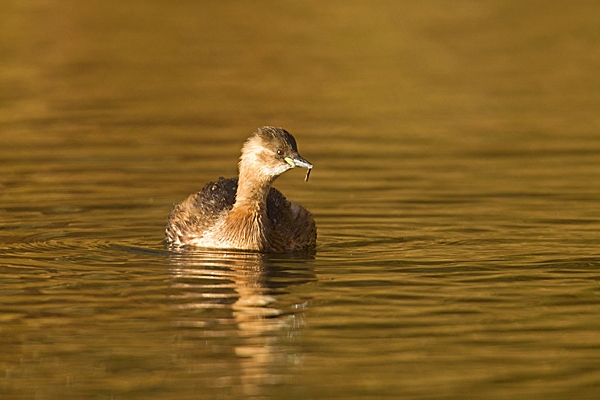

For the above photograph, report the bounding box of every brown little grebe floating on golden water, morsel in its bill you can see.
[166,126,317,253]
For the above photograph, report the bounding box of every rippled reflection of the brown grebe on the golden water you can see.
[164,250,315,394]
